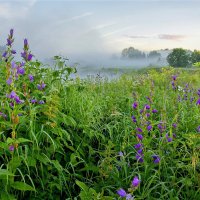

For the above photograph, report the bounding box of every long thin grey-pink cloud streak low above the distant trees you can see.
[125,34,187,41]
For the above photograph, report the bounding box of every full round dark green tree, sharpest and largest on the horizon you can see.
[167,48,190,67]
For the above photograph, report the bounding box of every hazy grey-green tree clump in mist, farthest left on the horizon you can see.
[121,47,146,59]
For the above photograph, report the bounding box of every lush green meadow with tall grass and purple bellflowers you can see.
[0,30,200,200]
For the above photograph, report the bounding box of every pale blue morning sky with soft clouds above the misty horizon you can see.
[0,0,200,59]
